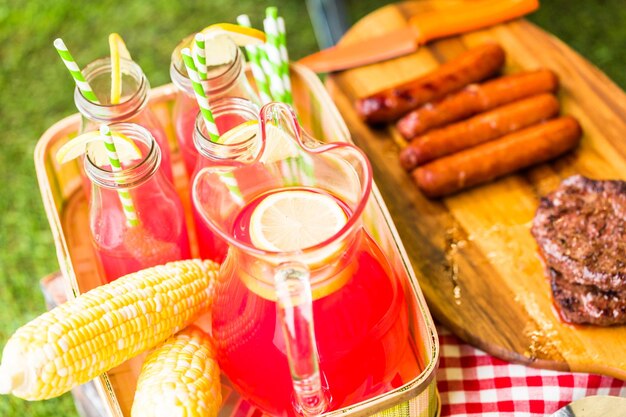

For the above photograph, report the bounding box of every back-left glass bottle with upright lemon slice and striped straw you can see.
[74,58,174,183]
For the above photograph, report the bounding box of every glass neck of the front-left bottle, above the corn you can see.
[85,123,161,190]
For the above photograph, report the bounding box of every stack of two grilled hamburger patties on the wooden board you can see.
[531,175,626,326]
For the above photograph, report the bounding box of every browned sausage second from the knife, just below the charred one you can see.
[396,69,559,139]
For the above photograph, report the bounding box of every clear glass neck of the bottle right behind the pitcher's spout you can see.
[193,97,261,162]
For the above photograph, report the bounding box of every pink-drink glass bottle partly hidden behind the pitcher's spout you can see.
[191,97,260,262]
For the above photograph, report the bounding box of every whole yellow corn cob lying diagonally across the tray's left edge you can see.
[0,260,218,400]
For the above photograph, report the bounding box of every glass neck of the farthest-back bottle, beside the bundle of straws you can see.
[170,35,244,99]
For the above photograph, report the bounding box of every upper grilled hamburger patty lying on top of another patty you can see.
[531,175,626,291]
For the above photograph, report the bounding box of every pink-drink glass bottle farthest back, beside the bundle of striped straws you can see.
[170,35,258,176]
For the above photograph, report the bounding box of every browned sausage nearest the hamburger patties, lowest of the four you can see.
[412,116,582,197]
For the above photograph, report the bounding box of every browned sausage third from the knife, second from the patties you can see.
[400,94,559,171]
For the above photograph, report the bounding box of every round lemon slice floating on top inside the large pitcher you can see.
[250,190,348,254]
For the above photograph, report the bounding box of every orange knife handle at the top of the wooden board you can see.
[409,0,539,44]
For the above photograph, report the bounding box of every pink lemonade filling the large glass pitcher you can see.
[213,187,410,416]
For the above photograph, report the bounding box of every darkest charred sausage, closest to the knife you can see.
[355,43,504,123]
